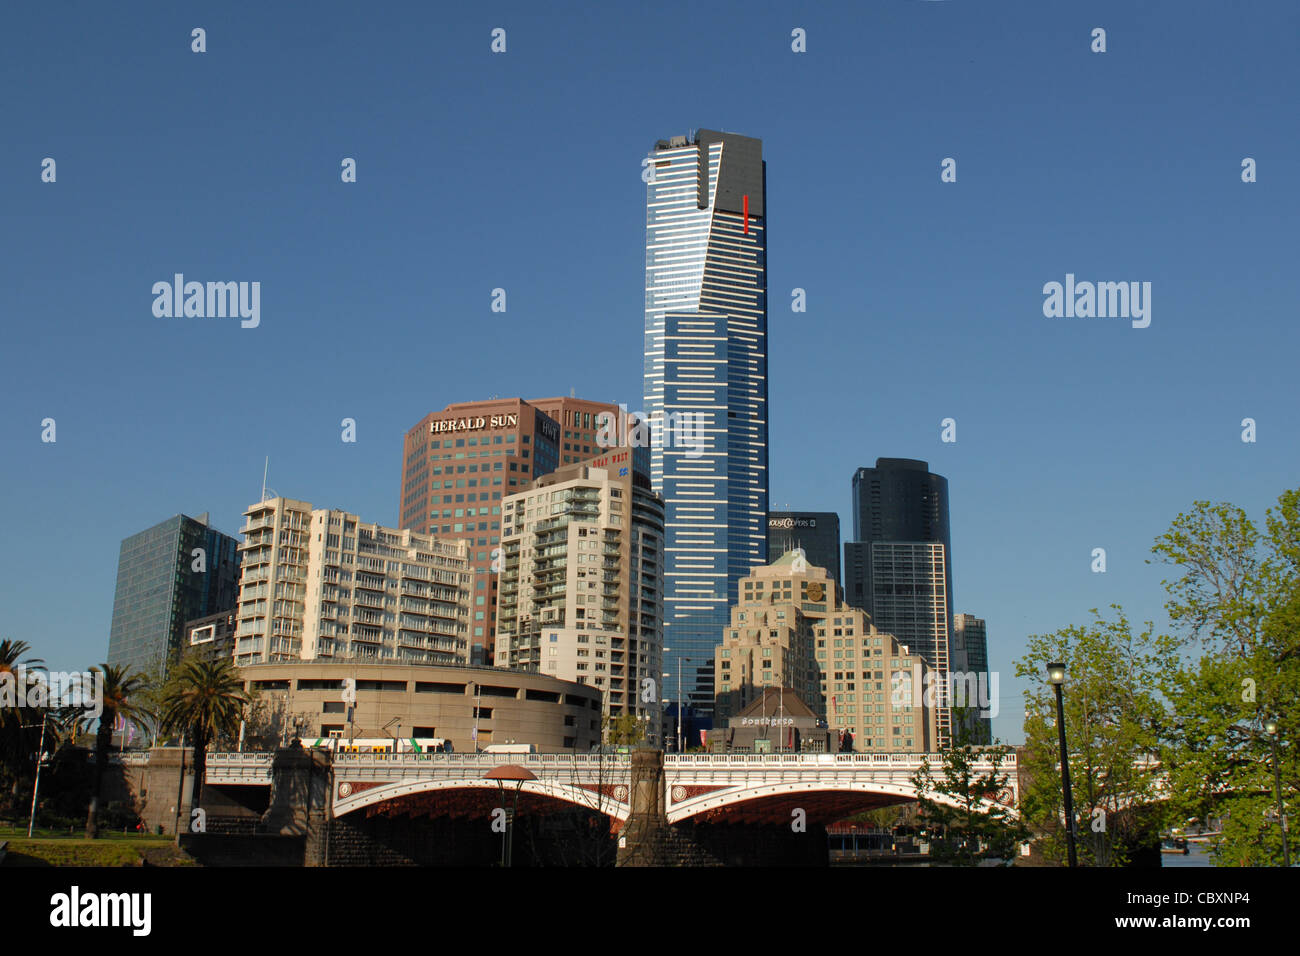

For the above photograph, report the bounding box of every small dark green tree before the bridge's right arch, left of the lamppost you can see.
[911,715,1030,866]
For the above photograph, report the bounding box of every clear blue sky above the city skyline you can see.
[0,0,1300,740]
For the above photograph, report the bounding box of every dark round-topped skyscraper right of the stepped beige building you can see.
[844,458,953,741]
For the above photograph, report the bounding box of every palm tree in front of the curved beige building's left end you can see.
[159,659,248,832]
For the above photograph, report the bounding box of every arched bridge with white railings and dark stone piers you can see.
[111,747,1021,866]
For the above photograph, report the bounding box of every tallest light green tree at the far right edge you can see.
[1152,490,1300,866]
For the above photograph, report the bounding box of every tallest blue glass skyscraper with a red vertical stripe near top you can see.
[645,130,767,723]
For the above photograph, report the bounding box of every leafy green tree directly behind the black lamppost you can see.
[1015,605,1178,866]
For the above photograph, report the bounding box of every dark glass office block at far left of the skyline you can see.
[108,512,239,670]
